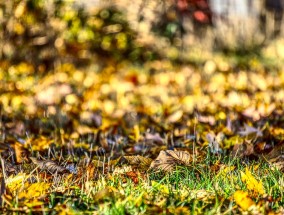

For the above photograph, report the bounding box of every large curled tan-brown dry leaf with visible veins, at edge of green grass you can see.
[150,150,192,172]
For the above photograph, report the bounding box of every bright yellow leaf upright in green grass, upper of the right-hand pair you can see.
[241,168,265,194]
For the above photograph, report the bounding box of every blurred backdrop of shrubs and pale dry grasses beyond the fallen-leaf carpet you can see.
[0,0,284,70]
